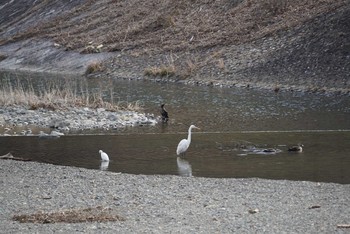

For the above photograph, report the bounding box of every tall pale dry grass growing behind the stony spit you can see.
[0,75,142,111]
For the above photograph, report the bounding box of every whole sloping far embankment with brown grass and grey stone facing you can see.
[0,0,350,92]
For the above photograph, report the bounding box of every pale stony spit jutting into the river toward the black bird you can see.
[0,106,157,136]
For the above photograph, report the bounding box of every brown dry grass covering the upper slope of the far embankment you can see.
[0,0,349,53]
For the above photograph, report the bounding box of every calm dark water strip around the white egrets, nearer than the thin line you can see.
[0,132,350,184]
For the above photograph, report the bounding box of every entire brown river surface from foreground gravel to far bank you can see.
[0,74,350,184]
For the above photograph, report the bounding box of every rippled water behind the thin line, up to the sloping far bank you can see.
[0,74,350,134]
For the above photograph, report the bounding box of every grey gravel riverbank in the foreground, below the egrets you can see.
[0,160,350,233]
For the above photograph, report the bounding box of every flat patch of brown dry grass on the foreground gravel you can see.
[12,206,125,224]
